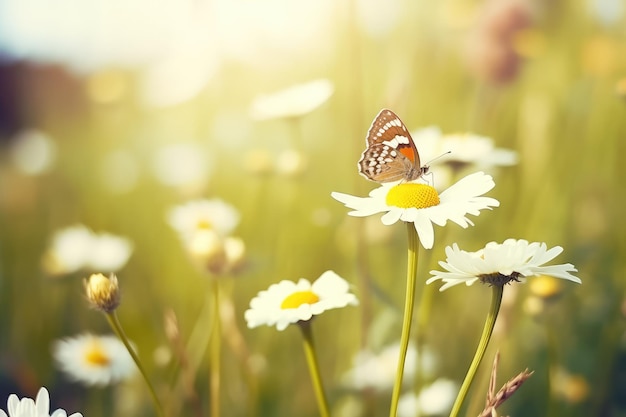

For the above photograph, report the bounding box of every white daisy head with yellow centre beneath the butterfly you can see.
[331,172,500,249]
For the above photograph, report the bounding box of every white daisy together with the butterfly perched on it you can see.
[331,109,500,249]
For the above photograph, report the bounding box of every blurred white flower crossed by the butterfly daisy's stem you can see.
[343,343,435,391]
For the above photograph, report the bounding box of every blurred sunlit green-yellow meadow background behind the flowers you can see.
[0,0,626,417]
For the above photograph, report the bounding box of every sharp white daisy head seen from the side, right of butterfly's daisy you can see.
[426,239,581,291]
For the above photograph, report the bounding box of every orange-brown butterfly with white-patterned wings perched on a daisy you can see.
[358,109,429,183]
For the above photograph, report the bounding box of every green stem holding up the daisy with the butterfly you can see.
[389,222,419,417]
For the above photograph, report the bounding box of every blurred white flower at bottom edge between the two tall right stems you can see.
[398,378,458,417]
